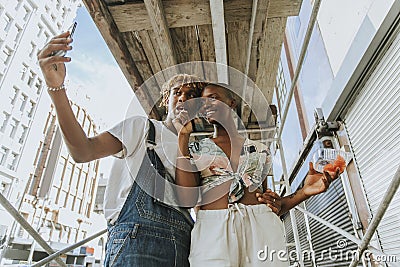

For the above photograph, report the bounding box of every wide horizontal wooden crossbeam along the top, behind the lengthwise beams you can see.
[109,0,302,32]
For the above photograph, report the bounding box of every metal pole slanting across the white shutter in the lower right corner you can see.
[350,166,400,267]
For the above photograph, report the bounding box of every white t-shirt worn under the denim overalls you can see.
[104,116,184,223]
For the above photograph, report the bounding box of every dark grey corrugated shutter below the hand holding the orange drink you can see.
[284,179,362,267]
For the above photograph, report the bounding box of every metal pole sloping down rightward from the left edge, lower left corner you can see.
[0,193,67,267]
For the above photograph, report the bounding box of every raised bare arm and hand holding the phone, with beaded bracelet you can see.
[38,32,122,162]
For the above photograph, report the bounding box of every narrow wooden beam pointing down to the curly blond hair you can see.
[144,0,177,67]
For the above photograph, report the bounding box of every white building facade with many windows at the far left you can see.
[0,0,81,258]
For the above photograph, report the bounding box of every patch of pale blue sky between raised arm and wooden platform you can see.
[62,6,144,131]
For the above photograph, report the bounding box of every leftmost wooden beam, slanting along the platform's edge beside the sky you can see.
[83,0,160,119]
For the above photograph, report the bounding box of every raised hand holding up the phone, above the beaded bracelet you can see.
[37,32,72,87]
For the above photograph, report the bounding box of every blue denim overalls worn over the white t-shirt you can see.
[104,120,193,267]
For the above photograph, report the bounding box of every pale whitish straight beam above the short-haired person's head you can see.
[210,0,229,83]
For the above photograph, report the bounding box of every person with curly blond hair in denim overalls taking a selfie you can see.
[38,32,202,267]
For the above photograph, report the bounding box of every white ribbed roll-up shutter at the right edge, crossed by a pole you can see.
[345,31,400,256]
